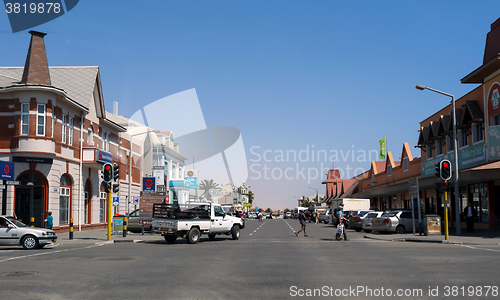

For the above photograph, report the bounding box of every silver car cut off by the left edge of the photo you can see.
[0,216,57,249]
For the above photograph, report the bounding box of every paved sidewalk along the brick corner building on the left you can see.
[56,229,163,245]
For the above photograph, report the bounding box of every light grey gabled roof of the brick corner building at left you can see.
[0,67,100,112]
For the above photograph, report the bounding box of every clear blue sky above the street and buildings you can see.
[0,0,500,209]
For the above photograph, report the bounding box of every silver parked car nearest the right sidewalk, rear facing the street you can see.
[372,210,418,234]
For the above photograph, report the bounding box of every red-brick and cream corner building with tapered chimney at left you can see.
[0,31,140,231]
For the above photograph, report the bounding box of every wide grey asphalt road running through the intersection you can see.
[0,219,500,299]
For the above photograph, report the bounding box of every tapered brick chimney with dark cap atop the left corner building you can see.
[21,30,51,85]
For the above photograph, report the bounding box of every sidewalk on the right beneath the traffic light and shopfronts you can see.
[364,228,500,245]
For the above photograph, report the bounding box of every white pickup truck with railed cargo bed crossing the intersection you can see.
[151,203,245,244]
